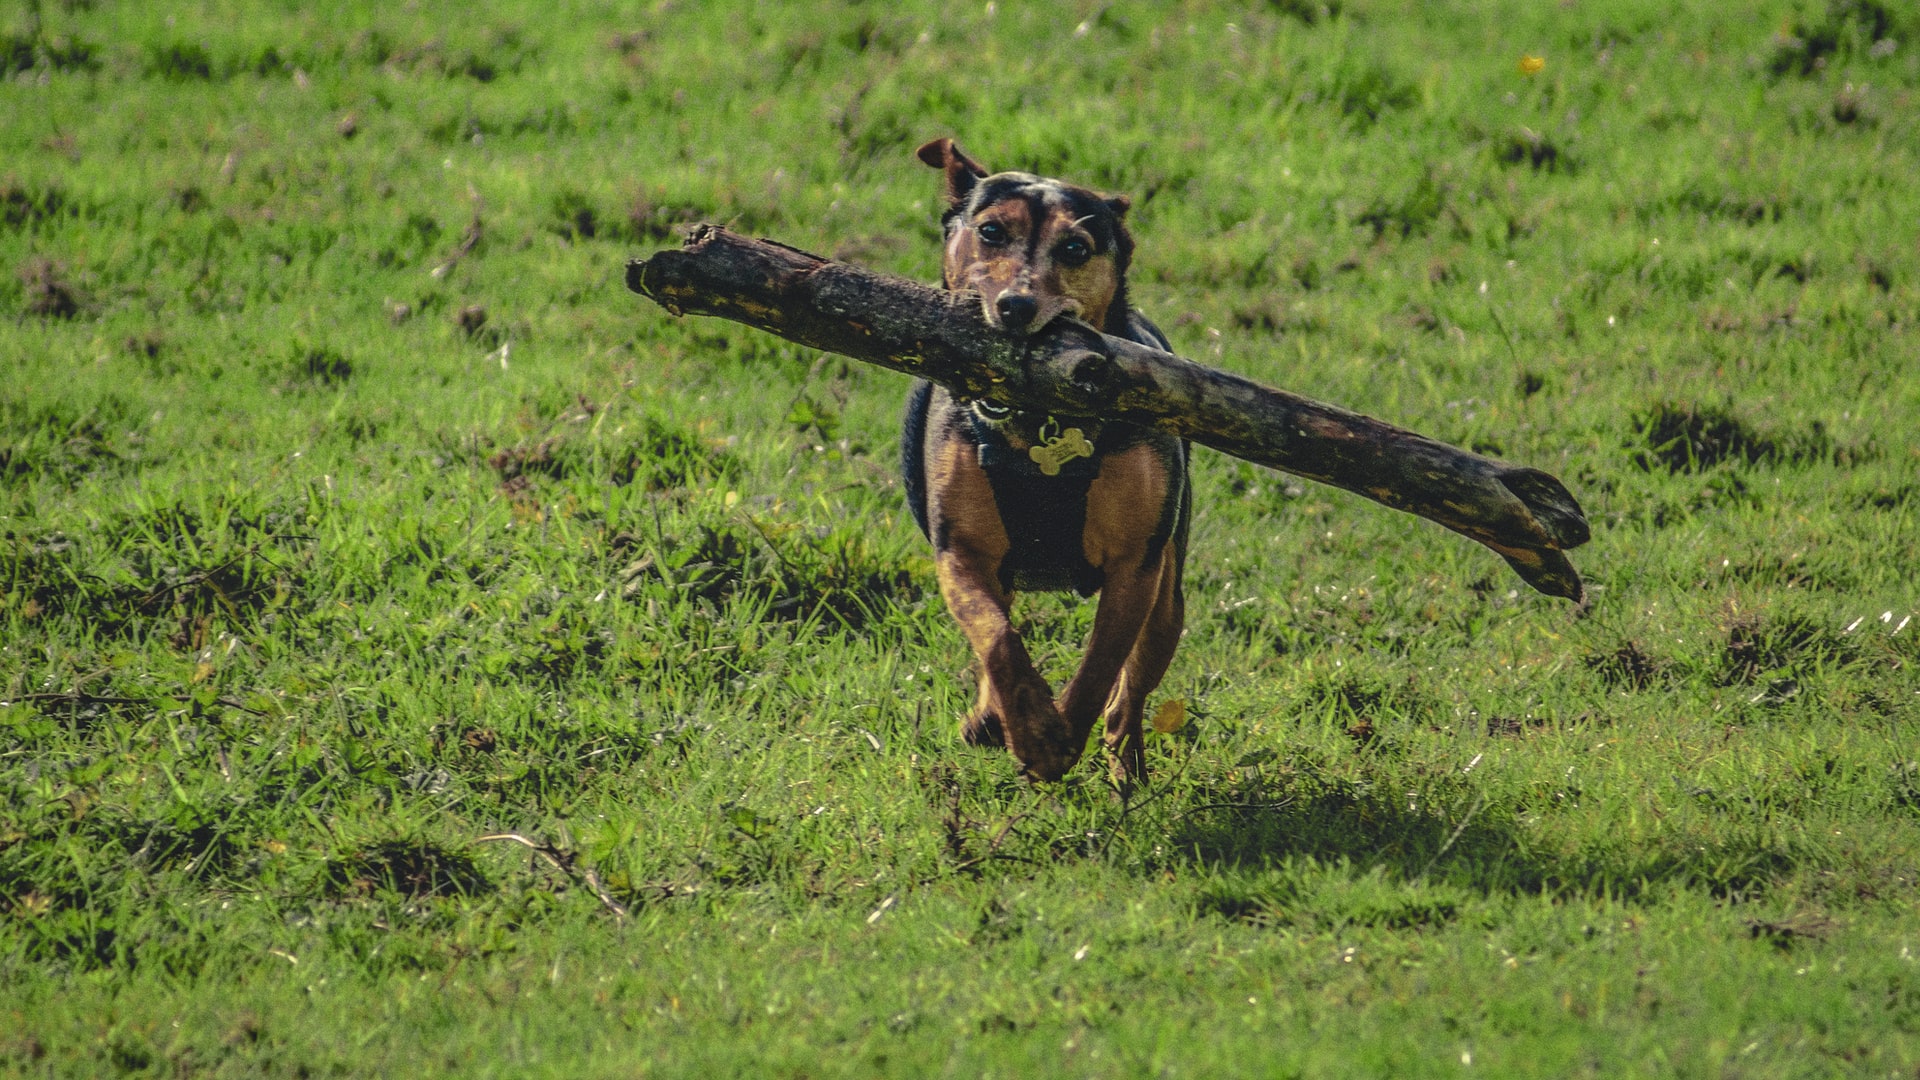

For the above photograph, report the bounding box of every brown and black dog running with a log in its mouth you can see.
[900,138,1192,790]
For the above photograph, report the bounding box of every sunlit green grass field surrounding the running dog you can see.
[0,0,1920,1078]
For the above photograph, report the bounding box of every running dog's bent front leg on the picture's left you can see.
[935,548,1087,780]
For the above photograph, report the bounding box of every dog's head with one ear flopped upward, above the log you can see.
[918,138,1133,334]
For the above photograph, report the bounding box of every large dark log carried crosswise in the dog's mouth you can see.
[626,225,1588,605]
